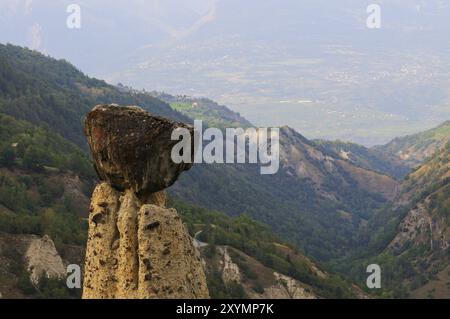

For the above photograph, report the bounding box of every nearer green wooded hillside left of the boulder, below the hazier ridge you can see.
[0,113,96,252]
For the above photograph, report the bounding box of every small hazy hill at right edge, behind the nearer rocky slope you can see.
[374,121,450,168]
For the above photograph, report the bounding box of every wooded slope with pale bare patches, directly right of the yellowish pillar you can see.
[173,200,361,299]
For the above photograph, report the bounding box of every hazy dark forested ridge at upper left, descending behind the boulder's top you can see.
[0,44,189,146]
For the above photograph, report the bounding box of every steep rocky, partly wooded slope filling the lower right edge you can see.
[338,143,450,298]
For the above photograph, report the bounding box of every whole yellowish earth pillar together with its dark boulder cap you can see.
[83,106,209,299]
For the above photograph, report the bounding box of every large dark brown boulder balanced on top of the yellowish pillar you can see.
[85,105,193,196]
